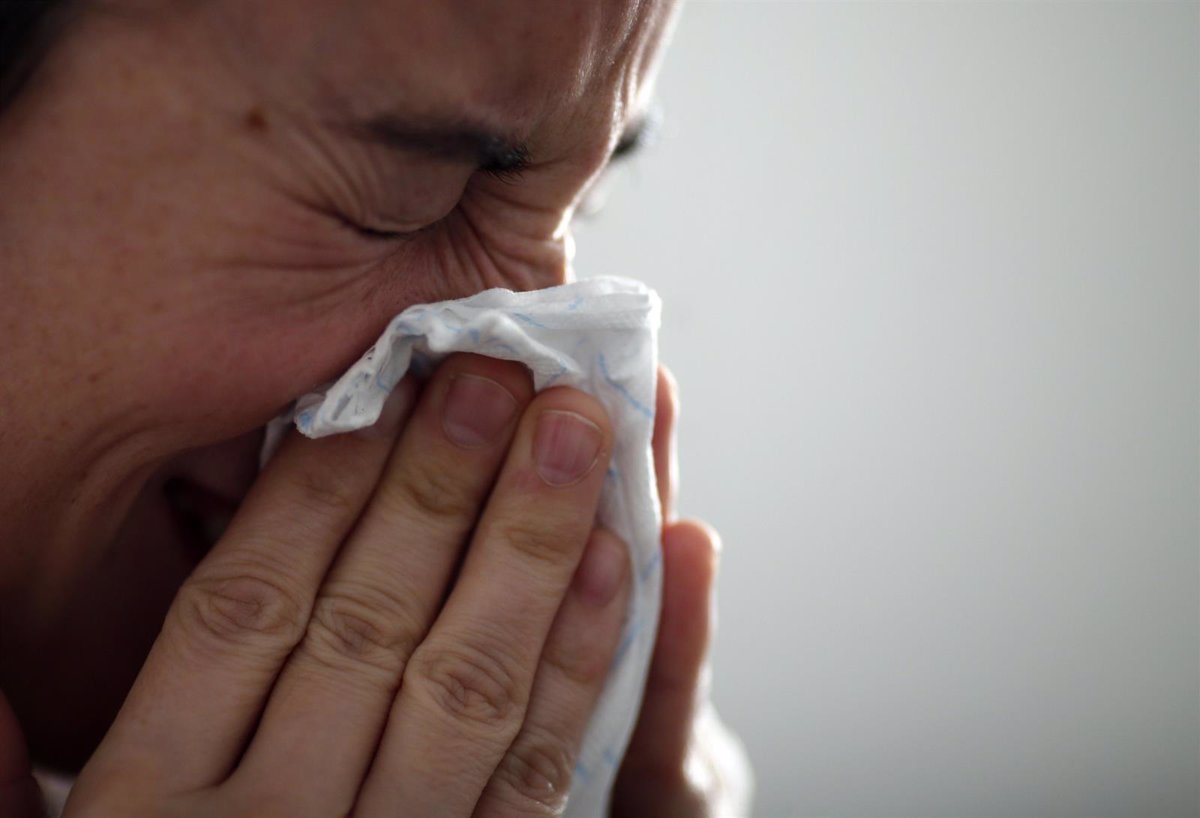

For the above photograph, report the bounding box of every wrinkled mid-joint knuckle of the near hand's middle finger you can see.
[305,587,421,681]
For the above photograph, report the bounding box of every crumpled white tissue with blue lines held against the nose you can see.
[263,277,662,818]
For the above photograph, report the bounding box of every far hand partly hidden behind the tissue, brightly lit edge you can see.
[612,369,752,818]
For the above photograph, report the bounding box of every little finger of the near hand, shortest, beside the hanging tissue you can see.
[475,529,629,818]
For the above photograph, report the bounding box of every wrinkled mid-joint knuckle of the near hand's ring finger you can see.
[404,643,526,732]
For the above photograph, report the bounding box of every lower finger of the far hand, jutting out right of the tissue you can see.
[614,522,719,786]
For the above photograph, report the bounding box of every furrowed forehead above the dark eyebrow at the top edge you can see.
[224,0,672,127]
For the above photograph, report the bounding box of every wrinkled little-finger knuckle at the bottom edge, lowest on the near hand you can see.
[493,733,575,816]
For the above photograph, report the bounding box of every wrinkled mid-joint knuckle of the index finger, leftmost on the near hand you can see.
[175,571,307,649]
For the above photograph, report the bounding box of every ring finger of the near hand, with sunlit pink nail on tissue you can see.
[359,389,612,818]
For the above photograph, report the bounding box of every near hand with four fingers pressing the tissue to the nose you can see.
[65,355,629,818]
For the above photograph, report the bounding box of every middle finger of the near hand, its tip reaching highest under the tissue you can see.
[230,355,533,818]
